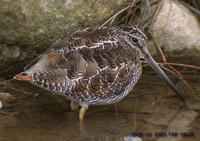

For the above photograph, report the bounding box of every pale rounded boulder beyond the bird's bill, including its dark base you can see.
[150,0,200,65]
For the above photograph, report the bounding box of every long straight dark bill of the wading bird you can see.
[142,48,185,100]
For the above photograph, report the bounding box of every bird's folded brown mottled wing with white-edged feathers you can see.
[25,28,137,95]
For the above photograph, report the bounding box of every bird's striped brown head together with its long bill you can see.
[119,26,185,100]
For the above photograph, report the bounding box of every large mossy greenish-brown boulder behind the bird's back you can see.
[0,0,126,76]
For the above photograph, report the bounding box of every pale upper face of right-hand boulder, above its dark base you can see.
[152,0,200,50]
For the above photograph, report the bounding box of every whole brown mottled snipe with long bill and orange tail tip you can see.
[15,26,184,120]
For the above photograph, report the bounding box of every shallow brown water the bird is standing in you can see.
[0,74,200,141]
